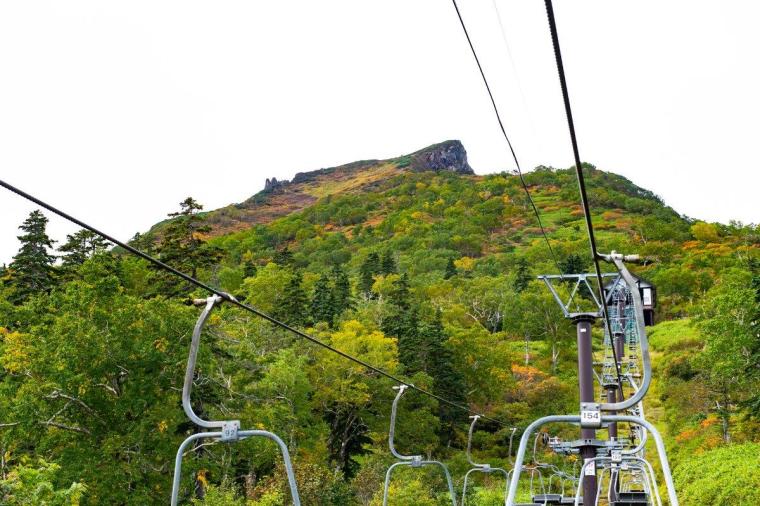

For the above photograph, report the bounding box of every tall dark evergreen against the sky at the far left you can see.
[8,210,55,303]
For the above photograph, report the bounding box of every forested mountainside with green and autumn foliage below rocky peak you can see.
[0,141,760,506]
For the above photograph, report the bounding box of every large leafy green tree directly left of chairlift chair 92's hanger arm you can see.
[0,274,199,504]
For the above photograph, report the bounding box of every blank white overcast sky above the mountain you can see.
[0,0,760,263]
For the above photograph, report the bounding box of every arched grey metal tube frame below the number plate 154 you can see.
[507,415,678,506]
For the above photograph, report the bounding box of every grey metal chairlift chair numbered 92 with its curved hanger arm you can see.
[171,295,301,506]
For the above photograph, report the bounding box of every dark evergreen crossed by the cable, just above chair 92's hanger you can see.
[155,197,221,295]
